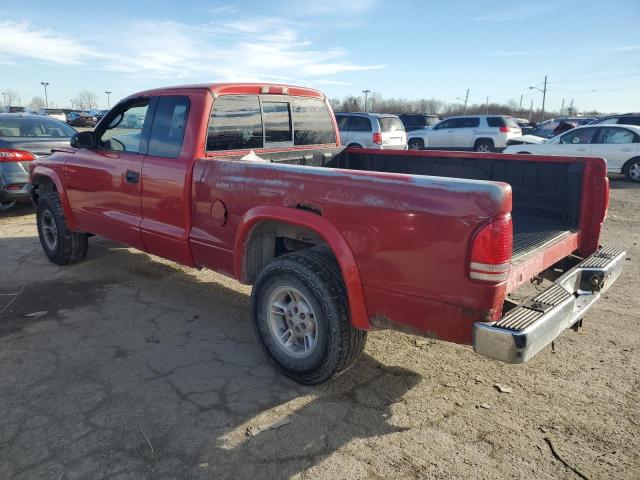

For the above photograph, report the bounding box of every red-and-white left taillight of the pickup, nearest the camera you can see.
[469,214,513,282]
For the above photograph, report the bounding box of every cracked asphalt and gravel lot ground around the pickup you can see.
[0,179,640,480]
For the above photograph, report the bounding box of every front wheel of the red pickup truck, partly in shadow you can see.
[36,193,89,265]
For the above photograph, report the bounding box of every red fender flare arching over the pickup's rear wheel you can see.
[234,206,371,330]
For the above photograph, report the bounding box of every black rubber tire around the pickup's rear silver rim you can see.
[251,249,367,385]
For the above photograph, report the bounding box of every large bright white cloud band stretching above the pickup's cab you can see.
[0,17,383,81]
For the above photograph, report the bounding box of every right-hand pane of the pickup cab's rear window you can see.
[291,98,336,145]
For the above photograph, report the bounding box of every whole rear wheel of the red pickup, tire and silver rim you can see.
[251,251,366,385]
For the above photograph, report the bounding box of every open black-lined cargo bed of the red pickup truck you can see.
[250,148,583,272]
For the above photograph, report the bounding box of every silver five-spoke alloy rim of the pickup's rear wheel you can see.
[267,286,318,358]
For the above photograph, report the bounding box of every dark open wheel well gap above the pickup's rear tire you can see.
[243,220,333,283]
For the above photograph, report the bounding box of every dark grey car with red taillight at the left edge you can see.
[0,113,76,211]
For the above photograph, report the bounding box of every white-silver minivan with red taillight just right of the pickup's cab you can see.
[336,113,407,150]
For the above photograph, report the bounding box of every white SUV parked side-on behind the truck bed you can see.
[409,115,522,152]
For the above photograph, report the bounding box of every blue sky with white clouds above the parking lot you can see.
[0,0,640,112]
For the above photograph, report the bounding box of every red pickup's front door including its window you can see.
[64,98,151,249]
